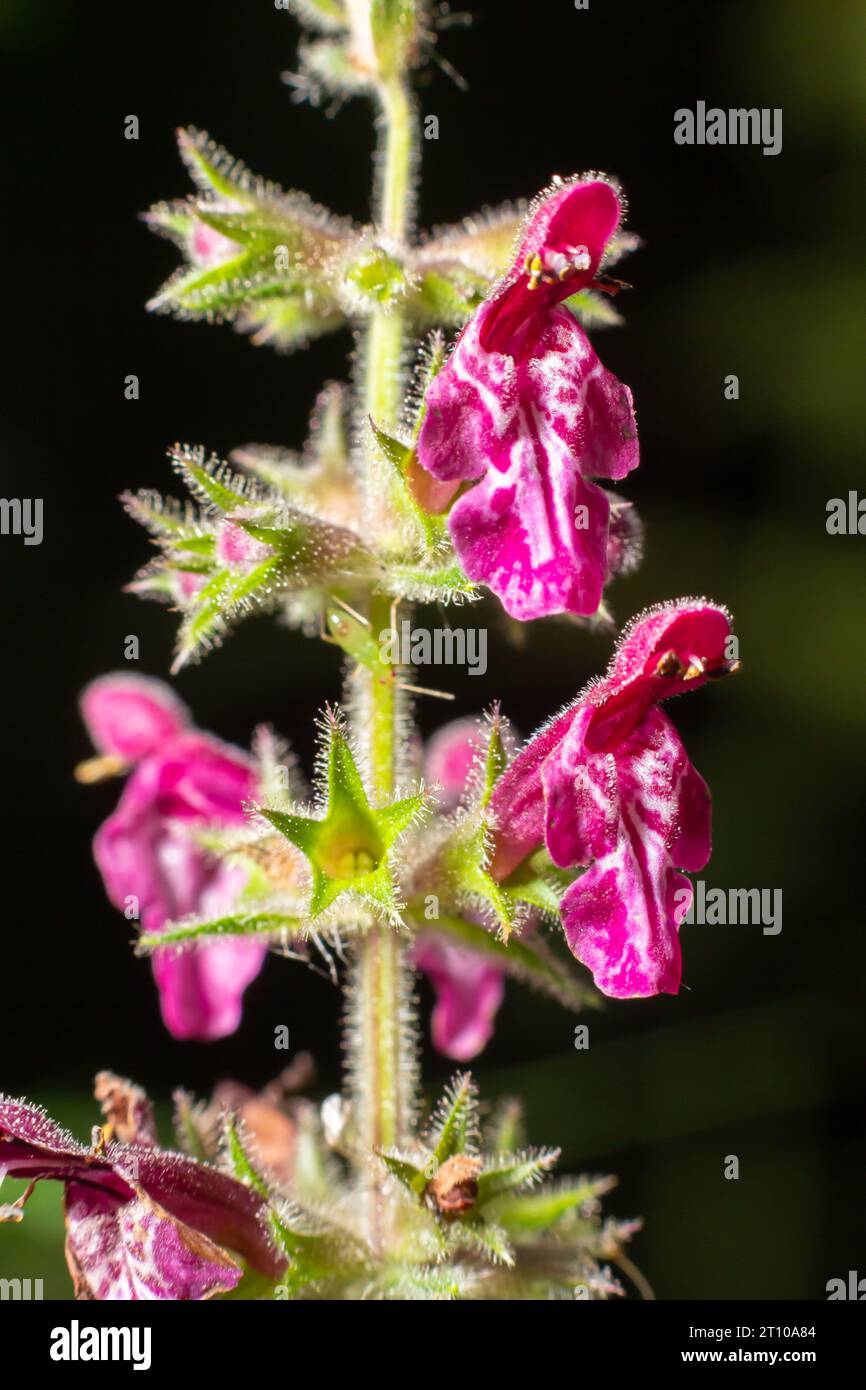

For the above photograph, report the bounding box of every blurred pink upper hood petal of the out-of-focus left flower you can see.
[81,671,189,765]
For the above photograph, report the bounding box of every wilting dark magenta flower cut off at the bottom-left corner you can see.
[0,1095,285,1300]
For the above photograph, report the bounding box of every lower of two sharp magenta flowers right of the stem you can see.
[491,599,738,998]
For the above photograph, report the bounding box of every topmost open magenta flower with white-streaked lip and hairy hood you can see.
[418,179,638,620]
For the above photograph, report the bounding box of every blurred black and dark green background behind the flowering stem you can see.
[0,0,866,1298]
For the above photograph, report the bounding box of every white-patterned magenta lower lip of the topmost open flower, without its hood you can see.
[418,306,638,620]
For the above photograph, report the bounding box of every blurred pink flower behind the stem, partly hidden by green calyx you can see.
[414,719,505,1062]
